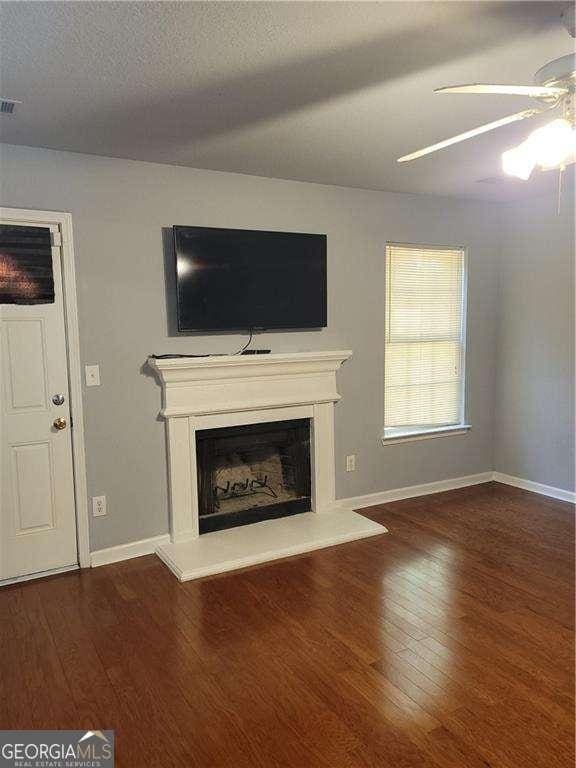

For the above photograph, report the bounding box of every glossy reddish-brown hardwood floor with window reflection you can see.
[0,483,574,768]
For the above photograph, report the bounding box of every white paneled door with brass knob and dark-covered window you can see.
[0,220,77,581]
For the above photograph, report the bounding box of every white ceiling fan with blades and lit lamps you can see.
[398,54,576,181]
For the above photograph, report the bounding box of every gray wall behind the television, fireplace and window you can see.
[0,146,499,549]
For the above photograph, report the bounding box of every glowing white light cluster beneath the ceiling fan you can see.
[502,118,576,181]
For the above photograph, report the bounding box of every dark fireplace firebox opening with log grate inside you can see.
[196,419,311,534]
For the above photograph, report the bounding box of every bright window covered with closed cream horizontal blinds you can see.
[384,244,468,440]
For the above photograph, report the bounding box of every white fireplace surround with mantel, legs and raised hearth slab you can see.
[149,350,386,580]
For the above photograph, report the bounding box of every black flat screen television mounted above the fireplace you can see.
[174,222,326,331]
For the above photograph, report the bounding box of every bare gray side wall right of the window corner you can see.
[495,186,575,491]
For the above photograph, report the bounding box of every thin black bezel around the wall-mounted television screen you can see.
[172,224,328,333]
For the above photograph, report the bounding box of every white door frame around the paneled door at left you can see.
[0,207,90,568]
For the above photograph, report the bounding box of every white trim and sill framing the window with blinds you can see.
[381,240,472,445]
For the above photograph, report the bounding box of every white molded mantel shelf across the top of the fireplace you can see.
[149,350,352,419]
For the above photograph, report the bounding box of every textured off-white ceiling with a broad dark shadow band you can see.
[0,0,574,199]
